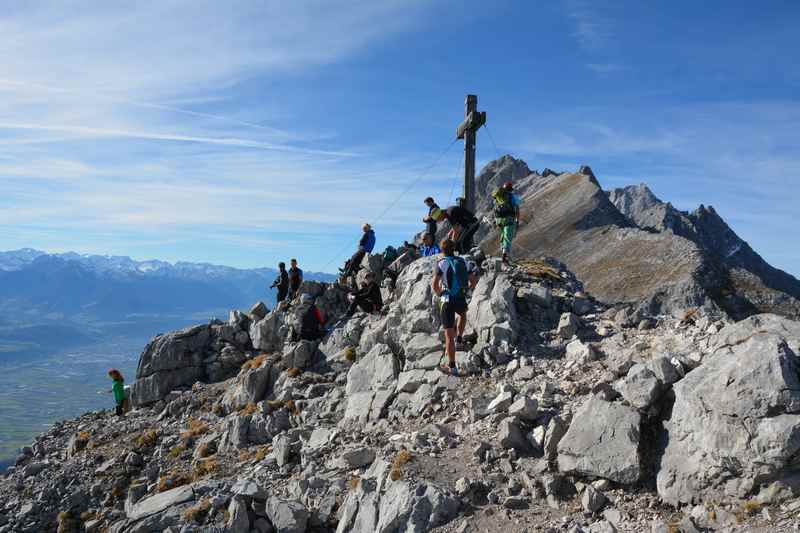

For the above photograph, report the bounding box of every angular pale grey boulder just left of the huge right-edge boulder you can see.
[558,397,641,485]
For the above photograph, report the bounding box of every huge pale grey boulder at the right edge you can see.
[657,317,800,504]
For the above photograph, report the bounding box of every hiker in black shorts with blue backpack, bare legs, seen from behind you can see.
[431,239,478,375]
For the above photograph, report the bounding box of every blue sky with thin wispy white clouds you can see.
[0,0,800,275]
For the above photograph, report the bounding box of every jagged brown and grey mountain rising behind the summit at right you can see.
[477,156,800,319]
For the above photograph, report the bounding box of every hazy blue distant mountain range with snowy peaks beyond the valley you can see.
[0,248,334,362]
